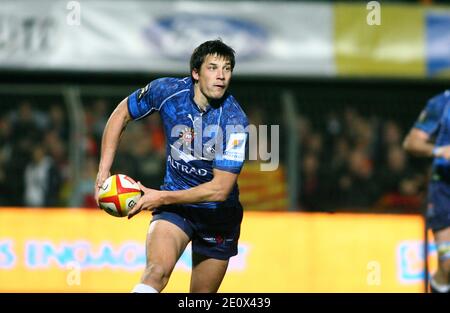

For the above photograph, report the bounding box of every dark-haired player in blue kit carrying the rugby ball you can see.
[96,40,248,292]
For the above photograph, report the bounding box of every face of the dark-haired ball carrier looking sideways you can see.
[192,54,231,100]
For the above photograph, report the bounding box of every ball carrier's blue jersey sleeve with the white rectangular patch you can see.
[212,102,248,174]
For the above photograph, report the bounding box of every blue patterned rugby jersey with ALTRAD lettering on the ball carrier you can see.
[128,77,248,209]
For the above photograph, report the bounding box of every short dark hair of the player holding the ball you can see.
[190,39,235,77]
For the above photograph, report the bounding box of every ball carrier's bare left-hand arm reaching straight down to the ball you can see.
[95,98,131,204]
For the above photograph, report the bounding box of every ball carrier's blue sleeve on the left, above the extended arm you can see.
[127,78,177,120]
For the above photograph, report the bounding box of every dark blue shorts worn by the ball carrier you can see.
[152,205,243,260]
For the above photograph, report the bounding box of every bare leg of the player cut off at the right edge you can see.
[430,227,450,292]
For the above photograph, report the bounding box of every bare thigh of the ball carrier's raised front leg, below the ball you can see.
[146,219,190,272]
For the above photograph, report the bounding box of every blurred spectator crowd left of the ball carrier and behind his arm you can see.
[0,99,165,208]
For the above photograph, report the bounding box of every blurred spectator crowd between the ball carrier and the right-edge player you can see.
[298,108,431,212]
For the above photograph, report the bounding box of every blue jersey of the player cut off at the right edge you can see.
[414,90,450,179]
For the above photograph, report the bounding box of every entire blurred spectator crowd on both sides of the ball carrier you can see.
[0,99,429,212]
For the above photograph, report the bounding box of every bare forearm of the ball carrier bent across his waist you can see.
[161,181,228,205]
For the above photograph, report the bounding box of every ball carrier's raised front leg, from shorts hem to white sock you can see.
[134,212,190,292]
